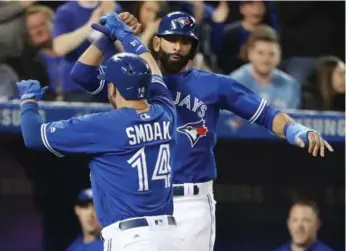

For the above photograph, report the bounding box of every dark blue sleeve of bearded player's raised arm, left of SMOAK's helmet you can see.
[71,61,106,95]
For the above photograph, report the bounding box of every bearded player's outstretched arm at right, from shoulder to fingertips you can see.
[218,75,333,157]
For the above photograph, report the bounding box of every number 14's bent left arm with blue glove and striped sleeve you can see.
[17,80,109,157]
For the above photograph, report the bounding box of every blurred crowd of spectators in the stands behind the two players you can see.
[0,0,345,111]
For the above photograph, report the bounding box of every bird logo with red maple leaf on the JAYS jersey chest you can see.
[177,119,208,147]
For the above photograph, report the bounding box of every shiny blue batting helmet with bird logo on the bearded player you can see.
[157,11,198,56]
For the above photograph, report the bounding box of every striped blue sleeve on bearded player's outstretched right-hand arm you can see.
[218,75,280,130]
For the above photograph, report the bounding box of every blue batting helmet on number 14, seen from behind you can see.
[101,53,152,100]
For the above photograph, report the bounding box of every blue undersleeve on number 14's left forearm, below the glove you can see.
[20,102,44,148]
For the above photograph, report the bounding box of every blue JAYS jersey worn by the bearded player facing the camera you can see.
[74,63,279,184]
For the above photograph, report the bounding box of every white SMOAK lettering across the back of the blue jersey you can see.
[126,121,172,145]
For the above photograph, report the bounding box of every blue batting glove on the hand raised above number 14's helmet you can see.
[91,12,133,41]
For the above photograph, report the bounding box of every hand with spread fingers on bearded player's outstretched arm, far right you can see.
[296,130,334,157]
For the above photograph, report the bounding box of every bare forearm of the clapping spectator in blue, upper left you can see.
[53,23,91,56]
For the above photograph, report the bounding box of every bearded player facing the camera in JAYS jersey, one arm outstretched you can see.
[71,12,333,251]
